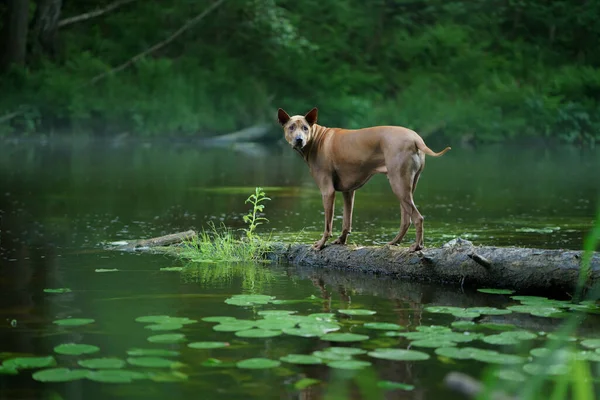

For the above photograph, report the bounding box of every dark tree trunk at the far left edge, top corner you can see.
[0,0,29,70]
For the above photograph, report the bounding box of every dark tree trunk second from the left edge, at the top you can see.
[31,0,62,57]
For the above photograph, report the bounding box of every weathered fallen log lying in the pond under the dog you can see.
[105,231,600,294]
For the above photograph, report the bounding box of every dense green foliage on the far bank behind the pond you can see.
[0,0,600,143]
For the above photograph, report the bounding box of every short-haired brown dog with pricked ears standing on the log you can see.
[277,108,450,251]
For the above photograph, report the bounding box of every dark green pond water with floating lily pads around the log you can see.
[0,141,600,399]
